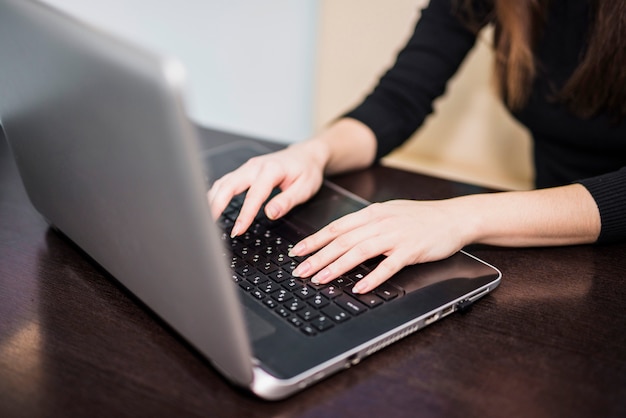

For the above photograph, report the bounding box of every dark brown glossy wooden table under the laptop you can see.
[0,128,626,418]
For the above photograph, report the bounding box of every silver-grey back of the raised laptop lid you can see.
[0,0,253,386]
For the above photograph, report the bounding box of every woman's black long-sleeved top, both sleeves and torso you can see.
[346,0,626,242]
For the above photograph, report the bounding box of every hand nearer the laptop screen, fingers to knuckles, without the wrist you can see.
[208,141,329,237]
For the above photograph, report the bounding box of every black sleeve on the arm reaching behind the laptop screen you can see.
[344,0,476,159]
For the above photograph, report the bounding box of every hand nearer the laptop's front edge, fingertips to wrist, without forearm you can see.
[291,199,470,293]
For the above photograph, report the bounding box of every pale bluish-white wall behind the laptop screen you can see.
[45,0,317,142]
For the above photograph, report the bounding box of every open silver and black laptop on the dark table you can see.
[0,0,501,400]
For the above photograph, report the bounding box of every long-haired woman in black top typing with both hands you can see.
[209,0,626,293]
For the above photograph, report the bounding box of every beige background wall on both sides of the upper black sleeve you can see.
[315,0,532,189]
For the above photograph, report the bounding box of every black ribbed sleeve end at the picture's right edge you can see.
[579,167,626,244]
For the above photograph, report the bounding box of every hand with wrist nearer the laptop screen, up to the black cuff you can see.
[208,118,376,237]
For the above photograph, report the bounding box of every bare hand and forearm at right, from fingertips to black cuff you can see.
[291,184,601,293]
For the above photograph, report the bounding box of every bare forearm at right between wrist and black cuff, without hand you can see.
[458,184,601,247]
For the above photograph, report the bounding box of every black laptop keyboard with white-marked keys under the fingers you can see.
[218,195,402,336]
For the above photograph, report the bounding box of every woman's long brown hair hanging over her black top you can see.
[461,0,626,119]
